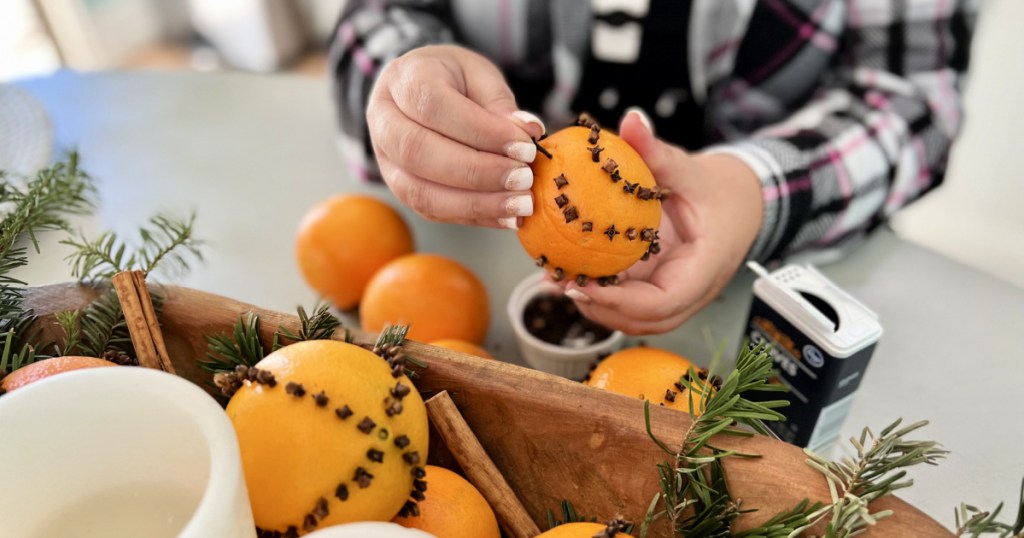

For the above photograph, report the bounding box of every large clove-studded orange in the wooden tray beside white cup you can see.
[226,340,427,533]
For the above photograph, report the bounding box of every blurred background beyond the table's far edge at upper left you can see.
[0,0,344,81]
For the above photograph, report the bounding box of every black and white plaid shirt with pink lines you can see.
[330,0,977,261]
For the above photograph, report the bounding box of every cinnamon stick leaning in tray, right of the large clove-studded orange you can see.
[426,390,541,538]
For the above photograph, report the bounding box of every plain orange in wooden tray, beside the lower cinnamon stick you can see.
[394,465,501,538]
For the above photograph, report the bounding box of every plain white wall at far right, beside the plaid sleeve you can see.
[893,0,1024,287]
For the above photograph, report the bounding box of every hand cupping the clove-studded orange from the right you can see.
[565,112,764,334]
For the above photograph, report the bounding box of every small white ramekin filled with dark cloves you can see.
[508,272,625,380]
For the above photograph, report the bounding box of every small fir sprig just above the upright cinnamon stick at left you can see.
[60,213,203,282]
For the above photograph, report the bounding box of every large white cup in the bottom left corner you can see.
[0,366,256,538]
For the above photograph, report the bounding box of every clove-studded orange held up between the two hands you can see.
[518,122,664,285]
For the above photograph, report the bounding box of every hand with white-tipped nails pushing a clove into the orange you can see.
[367,45,544,229]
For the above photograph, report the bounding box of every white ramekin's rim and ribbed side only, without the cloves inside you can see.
[508,272,625,380]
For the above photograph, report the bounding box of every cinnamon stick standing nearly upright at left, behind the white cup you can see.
[111,271,174,374]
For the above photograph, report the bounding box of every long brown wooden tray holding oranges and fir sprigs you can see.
[26,284,952,537]
